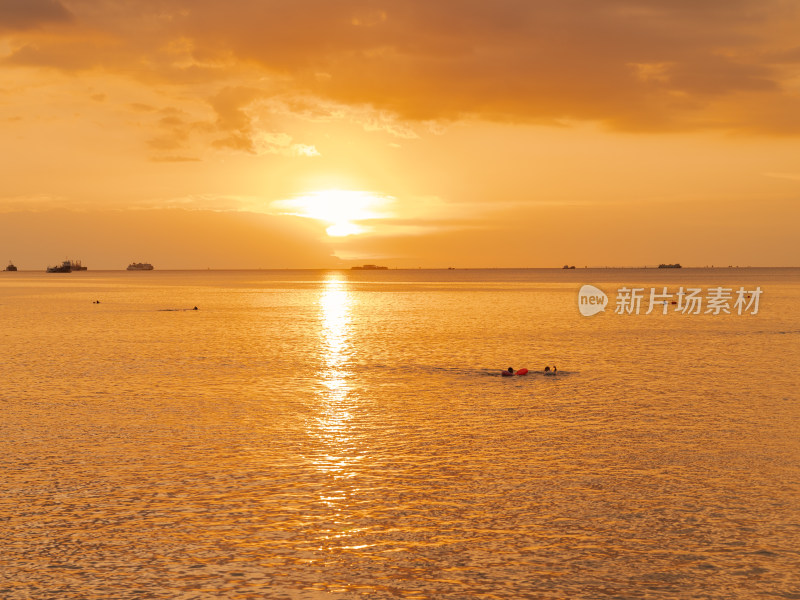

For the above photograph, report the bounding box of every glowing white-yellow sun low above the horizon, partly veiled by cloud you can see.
[273,190,394,237]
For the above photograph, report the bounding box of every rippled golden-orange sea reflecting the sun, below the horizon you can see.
[0,268,800,600]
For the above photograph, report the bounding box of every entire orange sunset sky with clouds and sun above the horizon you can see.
[0,0,800,270]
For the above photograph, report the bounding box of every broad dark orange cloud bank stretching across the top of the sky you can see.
[0,0,800,134]
